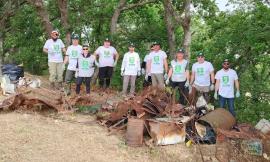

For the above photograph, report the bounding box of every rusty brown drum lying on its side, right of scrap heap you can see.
[198,108,236,131]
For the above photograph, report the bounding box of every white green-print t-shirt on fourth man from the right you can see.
[148,50,167,74]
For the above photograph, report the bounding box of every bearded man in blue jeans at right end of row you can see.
[214,59,240,116]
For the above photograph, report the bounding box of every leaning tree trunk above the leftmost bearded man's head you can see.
[27,0,53,36]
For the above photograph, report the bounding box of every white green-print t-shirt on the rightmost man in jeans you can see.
[215,69,238,98]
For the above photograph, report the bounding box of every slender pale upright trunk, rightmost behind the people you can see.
[182,0,191,61]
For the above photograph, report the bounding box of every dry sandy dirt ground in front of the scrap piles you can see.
[0,112,218,162]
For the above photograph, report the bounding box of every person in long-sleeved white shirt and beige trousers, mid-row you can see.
[121,43,141,96]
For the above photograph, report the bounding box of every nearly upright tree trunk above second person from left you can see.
[57,0,71,46]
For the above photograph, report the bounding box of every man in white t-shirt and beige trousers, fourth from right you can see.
[145,42,168,88]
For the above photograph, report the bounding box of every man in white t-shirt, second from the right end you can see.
[190,52,215,102]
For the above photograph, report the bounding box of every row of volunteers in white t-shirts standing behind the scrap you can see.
[43,30,240,115]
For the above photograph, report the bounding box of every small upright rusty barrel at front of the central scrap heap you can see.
[126,118,144,147]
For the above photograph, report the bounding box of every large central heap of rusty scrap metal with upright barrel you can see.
[97,88,219,146]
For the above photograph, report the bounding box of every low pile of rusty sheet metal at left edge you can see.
[0,88,71,112]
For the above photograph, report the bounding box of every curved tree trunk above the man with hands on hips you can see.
[110,0,127,36]
